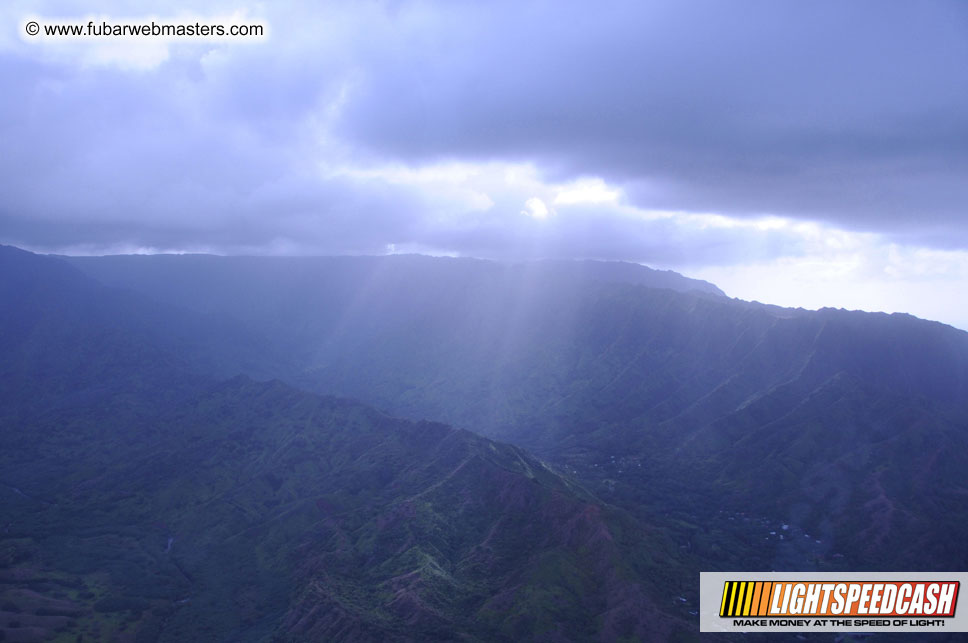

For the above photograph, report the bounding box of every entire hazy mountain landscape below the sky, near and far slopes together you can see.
[0,247,968,640]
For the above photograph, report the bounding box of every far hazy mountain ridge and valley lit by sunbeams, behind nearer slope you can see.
[58,248,968,580]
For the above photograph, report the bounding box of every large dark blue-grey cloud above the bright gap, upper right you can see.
[343,2,968,239]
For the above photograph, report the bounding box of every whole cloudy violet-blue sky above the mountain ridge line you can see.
[0,0,968,329]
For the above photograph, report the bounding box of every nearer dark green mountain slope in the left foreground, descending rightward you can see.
[0,245,688,641]
